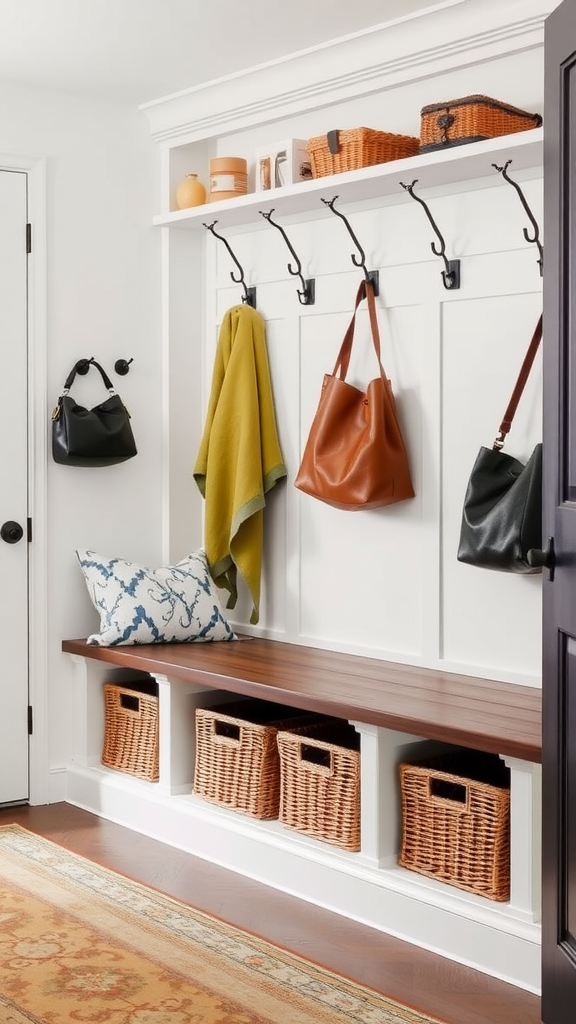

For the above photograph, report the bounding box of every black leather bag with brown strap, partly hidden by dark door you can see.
[457,316,542,573]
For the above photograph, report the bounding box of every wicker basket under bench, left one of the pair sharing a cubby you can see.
[193,700,319,819]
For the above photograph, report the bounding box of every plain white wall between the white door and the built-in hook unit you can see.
[0,86,161,797]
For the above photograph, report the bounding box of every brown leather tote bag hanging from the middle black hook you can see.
[294,281,414,511]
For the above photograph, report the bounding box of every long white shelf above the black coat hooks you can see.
[153,128,543,230]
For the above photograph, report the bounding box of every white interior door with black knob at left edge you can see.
[0,170,29,804]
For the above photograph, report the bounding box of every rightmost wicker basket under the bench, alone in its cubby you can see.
[399,751,510,901]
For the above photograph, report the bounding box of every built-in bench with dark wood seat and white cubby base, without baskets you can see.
[61,637,541,992]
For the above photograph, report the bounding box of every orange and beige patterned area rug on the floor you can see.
[0,825,444,1024]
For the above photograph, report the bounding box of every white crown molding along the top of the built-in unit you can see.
[139,0,553,145]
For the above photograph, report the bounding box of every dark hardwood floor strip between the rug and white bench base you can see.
[0,804,540,1024]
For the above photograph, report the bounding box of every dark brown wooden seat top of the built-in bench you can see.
[61,637,542,763]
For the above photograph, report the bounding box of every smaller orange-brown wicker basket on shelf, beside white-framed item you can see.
[307,128,419,178]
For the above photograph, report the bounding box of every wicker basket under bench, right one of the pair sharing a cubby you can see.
[278,721,360,851]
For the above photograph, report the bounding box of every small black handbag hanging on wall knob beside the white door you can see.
[52,358,137,466]
